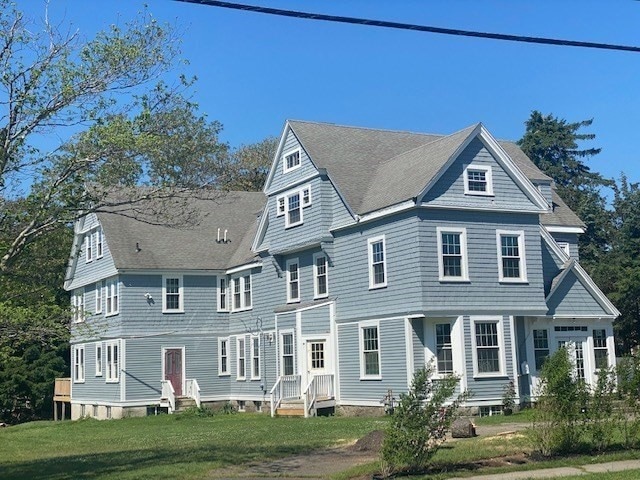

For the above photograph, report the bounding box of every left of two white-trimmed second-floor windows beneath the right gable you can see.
[436,227,469,282]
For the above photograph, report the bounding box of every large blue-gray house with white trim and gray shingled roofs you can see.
[65,121,619,418]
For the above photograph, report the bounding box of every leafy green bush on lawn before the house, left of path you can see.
[381,363,468,474]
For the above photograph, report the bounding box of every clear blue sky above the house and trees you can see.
[17,0,640,181]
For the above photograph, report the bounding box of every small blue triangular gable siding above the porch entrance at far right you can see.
[549,271,607,317]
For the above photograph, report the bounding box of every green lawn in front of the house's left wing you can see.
[0,414,387,480]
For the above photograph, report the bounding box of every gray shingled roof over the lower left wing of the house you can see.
[98,192,266,270]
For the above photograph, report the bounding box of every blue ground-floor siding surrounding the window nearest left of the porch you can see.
[463,315,515,404]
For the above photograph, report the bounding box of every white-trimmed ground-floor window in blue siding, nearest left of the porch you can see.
[471,317,505,376]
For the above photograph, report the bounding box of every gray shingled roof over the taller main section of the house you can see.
[289,121,551,214]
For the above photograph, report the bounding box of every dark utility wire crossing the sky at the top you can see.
[175,0,640,53]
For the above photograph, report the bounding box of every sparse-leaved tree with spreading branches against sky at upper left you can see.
[0,0,226,273]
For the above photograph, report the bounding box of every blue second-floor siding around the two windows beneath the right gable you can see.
[418,209,546,314]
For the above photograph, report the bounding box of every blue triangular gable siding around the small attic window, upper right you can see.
[424,138,537,210]
